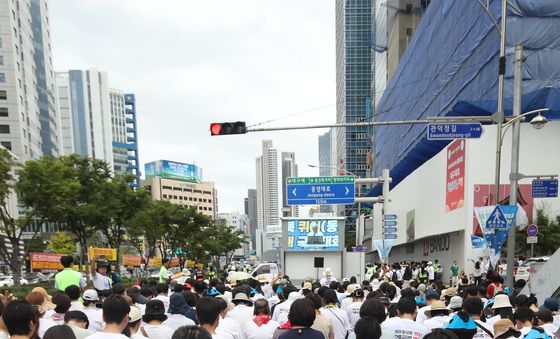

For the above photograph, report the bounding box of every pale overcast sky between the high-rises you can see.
[49,0,336,212]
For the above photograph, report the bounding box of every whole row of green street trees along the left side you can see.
[0,149,246,284]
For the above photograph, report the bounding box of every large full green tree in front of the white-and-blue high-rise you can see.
[18,154,111,270]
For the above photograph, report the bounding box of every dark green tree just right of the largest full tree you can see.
[95,175,149,261]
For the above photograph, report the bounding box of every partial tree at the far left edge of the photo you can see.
[0,148,37,286]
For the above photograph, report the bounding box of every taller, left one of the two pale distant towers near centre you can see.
[256,140,278,230]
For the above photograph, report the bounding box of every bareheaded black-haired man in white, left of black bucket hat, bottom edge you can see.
[87,295,130,339]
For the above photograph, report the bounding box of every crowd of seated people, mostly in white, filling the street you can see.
[0,257,560,339]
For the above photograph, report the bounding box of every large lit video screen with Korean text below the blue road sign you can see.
[283,219,344,251]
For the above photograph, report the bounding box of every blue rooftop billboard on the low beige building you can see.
[144,160,203,183]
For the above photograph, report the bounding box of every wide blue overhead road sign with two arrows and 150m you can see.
[286,176,355,205]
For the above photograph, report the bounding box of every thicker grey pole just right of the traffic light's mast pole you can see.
[506,45,523,288]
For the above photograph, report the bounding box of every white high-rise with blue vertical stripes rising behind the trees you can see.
[56,69,140,187]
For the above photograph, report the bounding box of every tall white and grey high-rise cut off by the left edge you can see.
[0,0,59,162]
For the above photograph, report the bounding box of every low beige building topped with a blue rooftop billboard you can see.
[141,160,217,219]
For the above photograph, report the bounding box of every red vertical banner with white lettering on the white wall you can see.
[445,139,466,212]
